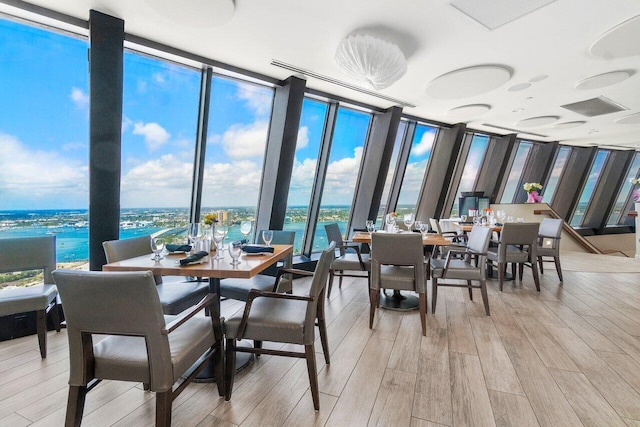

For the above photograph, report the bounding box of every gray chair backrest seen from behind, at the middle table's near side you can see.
[371,233,425,292]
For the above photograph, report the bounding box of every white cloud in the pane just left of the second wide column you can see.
[219,121,269,159]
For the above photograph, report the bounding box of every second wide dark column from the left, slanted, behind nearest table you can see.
[256,76,306,234]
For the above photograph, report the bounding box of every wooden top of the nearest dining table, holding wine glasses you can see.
[102,245,293,279]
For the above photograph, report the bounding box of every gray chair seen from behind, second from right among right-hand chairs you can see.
[487,222,540,291]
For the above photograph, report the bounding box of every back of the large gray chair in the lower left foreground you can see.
[53,270,173,390]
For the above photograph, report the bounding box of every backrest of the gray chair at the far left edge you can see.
[0,236,56,284]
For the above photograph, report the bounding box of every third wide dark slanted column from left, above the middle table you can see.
[349,107,402,234]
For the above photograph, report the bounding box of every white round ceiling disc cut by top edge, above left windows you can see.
[144,0,236,29]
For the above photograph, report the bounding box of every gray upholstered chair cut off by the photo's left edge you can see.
[0,236,60,359]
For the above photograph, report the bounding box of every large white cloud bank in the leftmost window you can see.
[0,134,89,209]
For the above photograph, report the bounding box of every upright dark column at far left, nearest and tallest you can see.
[89,10,124,270]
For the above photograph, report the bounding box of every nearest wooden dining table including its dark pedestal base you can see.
[102,245,293,382]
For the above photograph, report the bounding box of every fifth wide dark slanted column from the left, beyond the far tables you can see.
[476,134,517,203]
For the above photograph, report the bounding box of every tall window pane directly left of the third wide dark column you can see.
[313,107,371,251]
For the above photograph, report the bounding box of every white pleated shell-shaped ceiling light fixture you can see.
[335,34,407,90]
